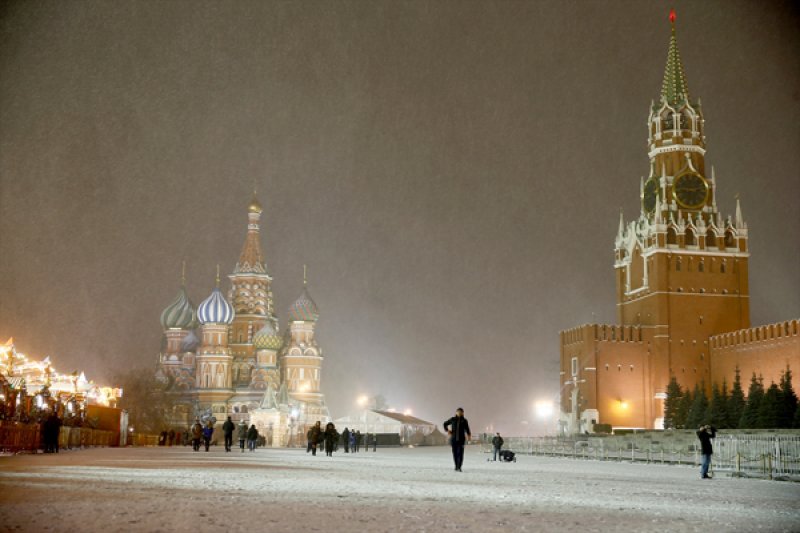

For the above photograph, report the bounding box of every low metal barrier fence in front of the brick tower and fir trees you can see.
[481,434,800,480]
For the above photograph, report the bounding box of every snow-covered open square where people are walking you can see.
[0,447,800,533]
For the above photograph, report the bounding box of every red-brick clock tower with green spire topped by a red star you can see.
[560,12,800,432]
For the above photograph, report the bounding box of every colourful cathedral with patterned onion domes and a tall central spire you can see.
[156,193,330,446]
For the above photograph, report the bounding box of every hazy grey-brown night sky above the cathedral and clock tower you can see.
[0,1,800,433]
